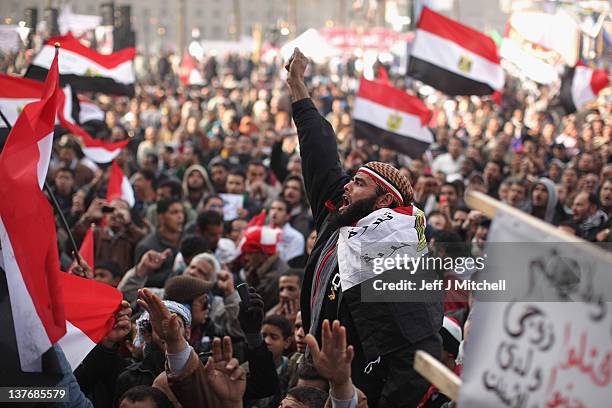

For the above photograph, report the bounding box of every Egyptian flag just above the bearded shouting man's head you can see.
[353,79,433,158]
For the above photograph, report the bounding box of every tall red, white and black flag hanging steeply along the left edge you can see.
[0,45,66,372]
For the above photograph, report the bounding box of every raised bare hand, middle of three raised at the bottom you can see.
[204,336,246,403]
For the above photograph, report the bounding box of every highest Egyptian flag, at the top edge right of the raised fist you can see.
[408,7,505,95]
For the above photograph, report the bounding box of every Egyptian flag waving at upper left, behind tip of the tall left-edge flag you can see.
[26,33,136,96]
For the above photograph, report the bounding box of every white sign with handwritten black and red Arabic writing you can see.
[459,210,612,408]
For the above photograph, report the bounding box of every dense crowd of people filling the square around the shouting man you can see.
[1,35,612,408]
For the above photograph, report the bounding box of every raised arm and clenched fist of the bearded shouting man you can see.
[285,48,349,230]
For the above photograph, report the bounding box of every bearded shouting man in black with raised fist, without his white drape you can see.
[285,49,443,407]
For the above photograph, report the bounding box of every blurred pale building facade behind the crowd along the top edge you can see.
[0,0,511,52]
